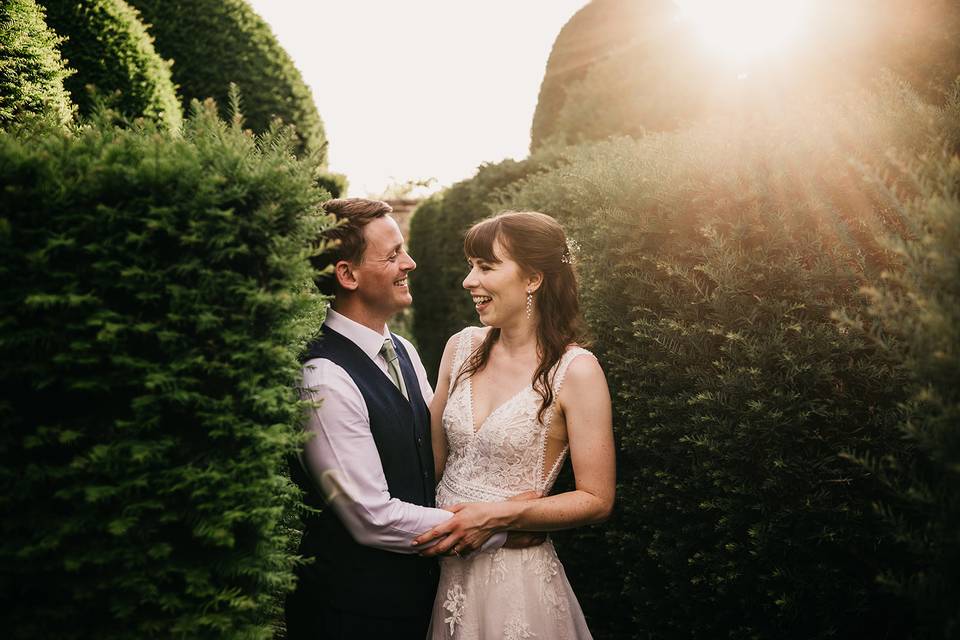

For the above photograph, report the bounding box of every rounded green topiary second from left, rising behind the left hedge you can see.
[40,0,183,129]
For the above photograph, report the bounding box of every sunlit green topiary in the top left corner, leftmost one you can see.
[0,0,73,128]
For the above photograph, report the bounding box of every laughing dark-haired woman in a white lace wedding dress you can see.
[414,212,615,640]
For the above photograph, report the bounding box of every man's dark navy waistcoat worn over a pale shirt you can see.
[294,327,439,617]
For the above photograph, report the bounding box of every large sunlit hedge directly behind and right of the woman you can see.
[498,82,940,638]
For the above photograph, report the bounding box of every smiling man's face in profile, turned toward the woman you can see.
[353,216,417,315]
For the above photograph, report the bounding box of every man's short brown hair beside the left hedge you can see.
[311,198,393,295]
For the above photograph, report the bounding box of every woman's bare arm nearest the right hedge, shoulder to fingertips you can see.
[414,357,616,555]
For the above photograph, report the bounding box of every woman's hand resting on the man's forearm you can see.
[413,502,513,556]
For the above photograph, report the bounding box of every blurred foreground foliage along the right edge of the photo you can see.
[854,146,960,640]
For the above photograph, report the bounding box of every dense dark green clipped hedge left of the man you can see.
[0,102,329,639]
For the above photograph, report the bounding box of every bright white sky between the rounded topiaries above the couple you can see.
[250,0,587,196]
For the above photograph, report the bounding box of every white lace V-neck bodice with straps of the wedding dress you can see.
[437,327,592,507]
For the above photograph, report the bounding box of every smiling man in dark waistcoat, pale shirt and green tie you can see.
[286,198,506,640]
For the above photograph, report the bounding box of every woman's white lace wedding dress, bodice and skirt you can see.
[429,327,591,640]
